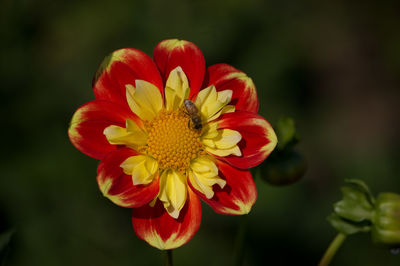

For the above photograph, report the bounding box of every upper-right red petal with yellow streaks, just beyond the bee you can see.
[203,64,258,113]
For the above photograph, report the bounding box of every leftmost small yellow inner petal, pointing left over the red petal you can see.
[103,119,147,147]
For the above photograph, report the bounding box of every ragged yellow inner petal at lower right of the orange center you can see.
[189,156,226,199]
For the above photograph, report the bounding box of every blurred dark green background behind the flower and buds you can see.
[0,0,400,266]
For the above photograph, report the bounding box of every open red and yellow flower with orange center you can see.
[68,39,277,249]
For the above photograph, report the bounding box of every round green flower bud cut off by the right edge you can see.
[372,193,400,246]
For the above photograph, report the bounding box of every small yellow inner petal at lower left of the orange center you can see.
[120,155,158,185]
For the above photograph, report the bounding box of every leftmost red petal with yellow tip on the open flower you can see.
[68,100,141,159]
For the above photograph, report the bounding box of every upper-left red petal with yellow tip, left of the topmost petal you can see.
[92,48,164,105]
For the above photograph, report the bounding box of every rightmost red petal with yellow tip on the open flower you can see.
[214,111,277,169]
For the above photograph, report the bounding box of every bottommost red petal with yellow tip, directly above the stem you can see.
[132,189,201,249]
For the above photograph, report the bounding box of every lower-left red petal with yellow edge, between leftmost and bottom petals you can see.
[97,148,159,208]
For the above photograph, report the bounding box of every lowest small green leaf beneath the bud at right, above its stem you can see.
[328,213,371,235]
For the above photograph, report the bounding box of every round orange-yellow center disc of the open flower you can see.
[145,109,203,172]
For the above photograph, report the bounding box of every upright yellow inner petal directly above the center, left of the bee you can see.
[165,66,190,111]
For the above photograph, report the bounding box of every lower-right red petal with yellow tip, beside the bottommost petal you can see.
[190,160,257,215]
